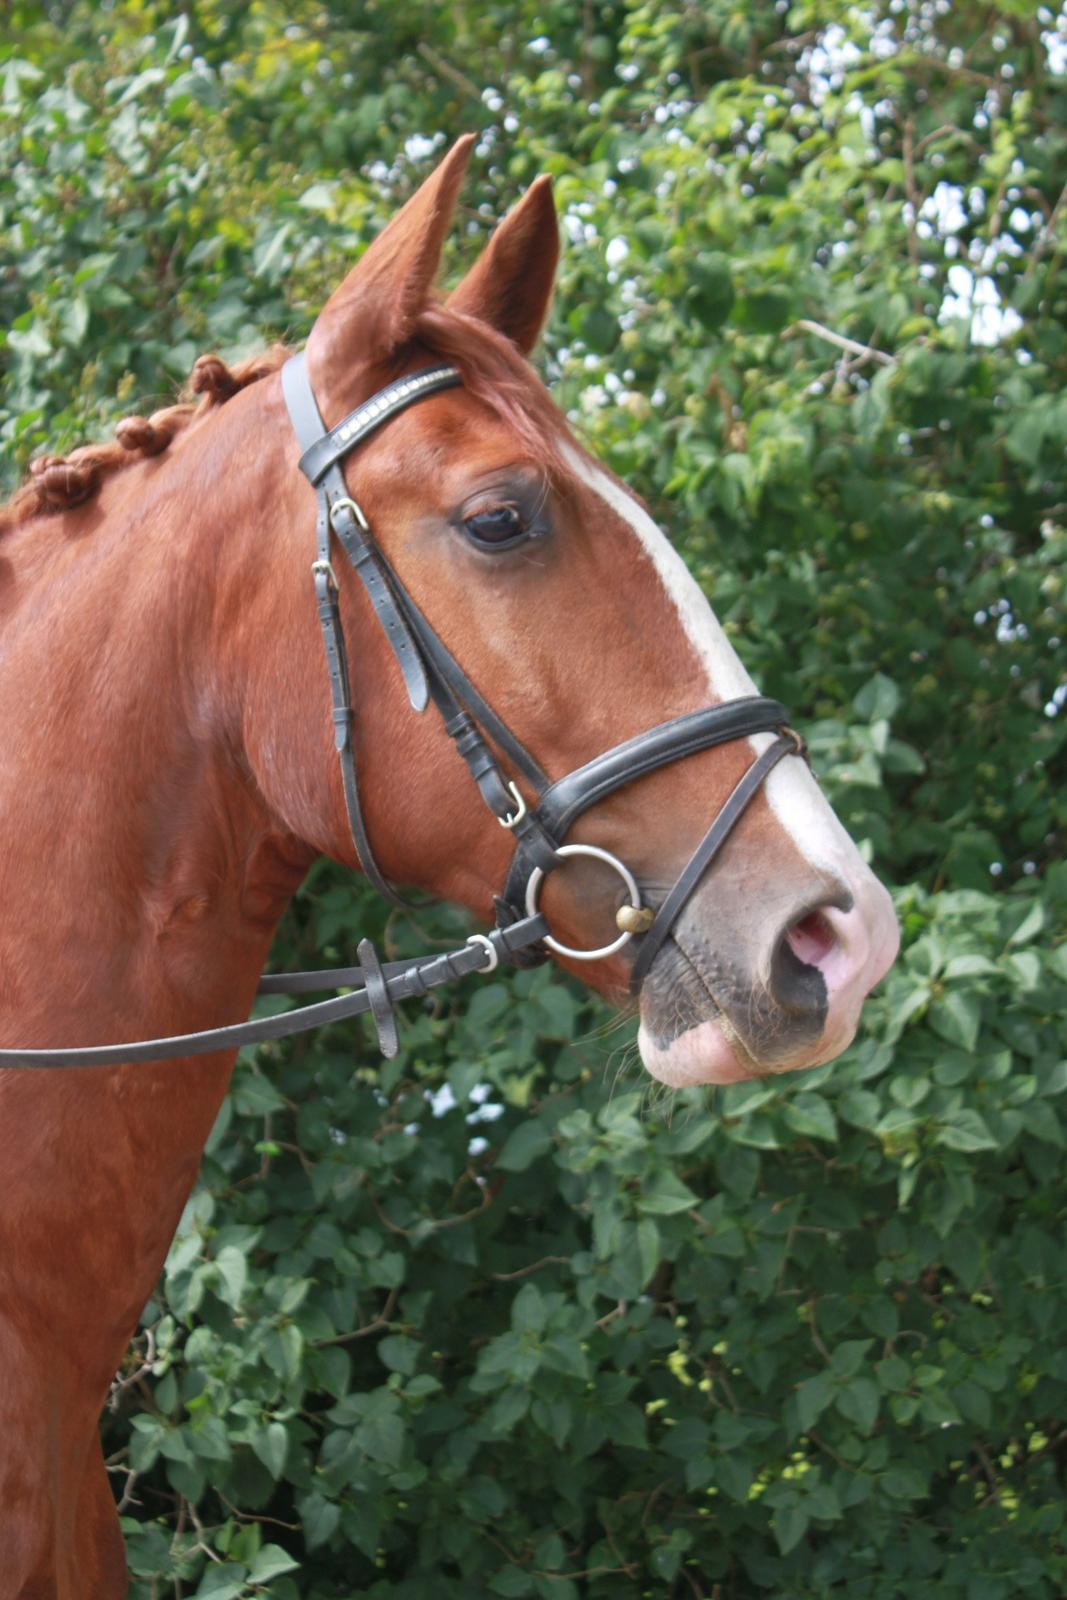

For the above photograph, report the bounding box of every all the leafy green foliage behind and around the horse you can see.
[0,0,1067,1600]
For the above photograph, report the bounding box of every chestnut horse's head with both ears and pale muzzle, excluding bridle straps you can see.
[235,139,897,1085]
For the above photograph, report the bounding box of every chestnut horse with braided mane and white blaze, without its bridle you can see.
[0,139,896,1600]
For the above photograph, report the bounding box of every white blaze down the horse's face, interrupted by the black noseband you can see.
[566,446,867,883]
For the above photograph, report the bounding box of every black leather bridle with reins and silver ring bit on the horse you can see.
[0,354,803,1067]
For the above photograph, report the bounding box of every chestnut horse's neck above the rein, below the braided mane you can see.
[0,379,330,1045]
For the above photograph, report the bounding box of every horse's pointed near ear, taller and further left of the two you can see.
[307,133,475,389]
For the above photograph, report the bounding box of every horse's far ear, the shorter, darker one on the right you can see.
[448,178,560,355]
